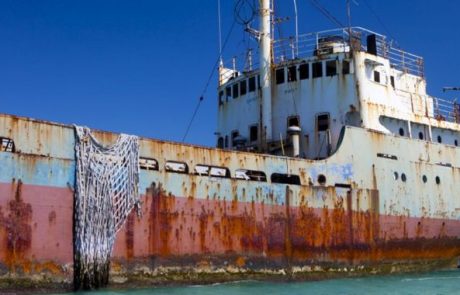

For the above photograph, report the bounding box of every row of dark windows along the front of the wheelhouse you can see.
[219,60,350,105]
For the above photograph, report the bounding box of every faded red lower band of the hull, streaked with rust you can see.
[0,183,460,276]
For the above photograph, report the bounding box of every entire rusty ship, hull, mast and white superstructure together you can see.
[0,0,460,292]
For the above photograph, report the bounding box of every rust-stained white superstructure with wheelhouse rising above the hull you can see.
[217,15,460,159]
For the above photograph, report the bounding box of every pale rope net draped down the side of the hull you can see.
[74,126,140,289]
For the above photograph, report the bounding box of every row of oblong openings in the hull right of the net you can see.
[139,158,332,185]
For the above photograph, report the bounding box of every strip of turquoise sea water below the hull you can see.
[63,270,460,295]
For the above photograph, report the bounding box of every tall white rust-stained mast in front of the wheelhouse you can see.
[259,0,273,144]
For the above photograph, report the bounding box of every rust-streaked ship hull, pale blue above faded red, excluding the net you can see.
[0,115,460,288]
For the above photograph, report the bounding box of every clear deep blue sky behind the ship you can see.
[0,0,460,145]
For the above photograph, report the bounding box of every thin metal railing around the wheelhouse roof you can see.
[221,27,424,77]
